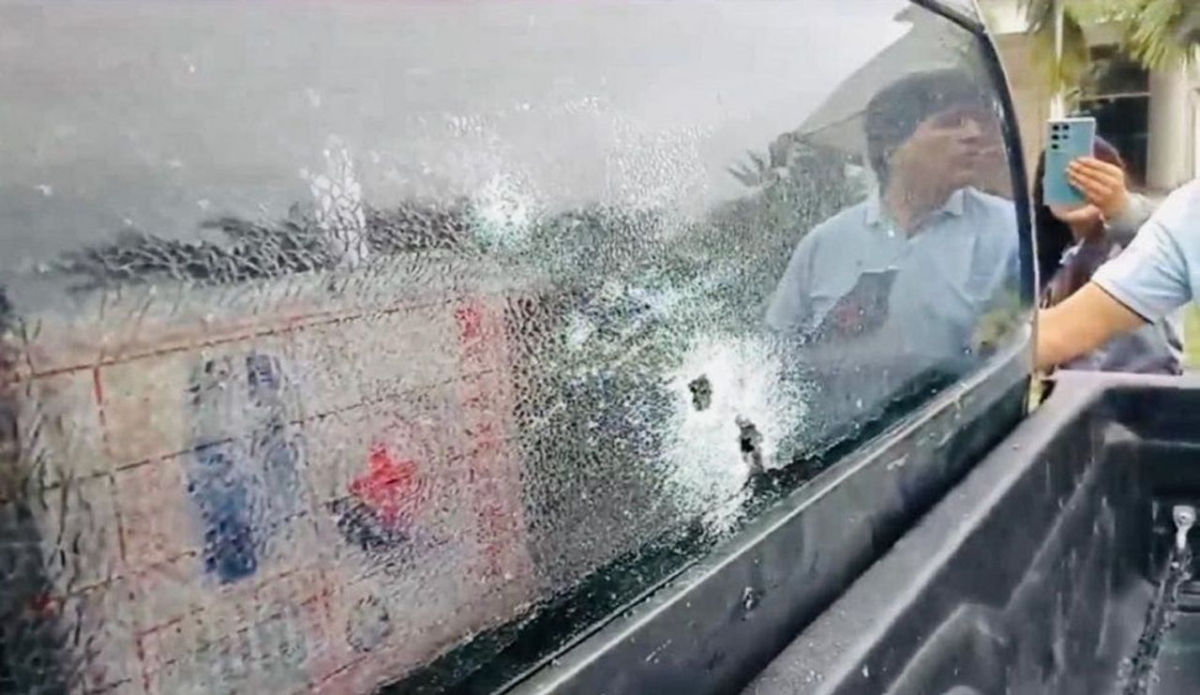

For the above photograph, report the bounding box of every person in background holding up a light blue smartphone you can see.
[1033,138,1183,375]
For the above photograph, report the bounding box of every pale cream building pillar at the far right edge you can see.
[1146,67,1192,192]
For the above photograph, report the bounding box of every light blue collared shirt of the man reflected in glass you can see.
[767,188,1019,361]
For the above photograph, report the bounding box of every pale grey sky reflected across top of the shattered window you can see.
[0,0,905,279]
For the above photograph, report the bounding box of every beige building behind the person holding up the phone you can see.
[980,0,1200,191]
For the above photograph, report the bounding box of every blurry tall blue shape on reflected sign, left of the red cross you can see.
[186,353,300,583]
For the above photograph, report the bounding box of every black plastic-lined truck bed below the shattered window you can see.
[746,375,1200,695]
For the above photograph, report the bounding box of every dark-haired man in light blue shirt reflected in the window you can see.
[767,71,1019,424]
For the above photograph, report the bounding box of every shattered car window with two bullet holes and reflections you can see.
[0,0,1026,694]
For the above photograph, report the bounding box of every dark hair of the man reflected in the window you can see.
[865,68,992,181]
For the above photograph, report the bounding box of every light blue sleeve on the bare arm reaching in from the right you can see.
[1092,216,1200,322]
